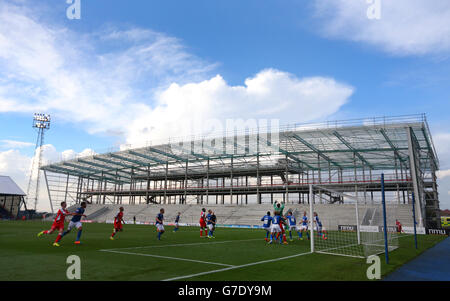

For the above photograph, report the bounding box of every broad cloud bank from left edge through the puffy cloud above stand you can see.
[0,0,354,148]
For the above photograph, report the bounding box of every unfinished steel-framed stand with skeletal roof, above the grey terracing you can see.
[42,115,439,226]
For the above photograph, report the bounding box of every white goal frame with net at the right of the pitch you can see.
[309,179,398,258]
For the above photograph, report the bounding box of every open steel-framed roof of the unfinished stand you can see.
[42,115,439,183]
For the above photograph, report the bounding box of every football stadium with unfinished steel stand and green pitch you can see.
[1,114,445,281]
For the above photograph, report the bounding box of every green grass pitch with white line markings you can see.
[0,221,444,281]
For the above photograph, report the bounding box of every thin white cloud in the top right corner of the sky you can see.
[314,0,450,56]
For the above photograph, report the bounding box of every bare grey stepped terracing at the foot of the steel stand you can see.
[74,200,412,230]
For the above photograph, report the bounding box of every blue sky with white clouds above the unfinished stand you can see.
[0,0,450,208]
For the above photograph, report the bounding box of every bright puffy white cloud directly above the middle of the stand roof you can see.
[127,69,354,144]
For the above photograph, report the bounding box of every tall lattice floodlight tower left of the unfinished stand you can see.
[27,113,50,210]
